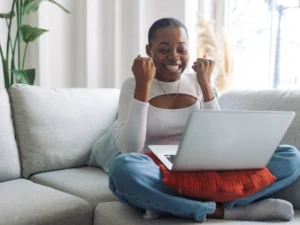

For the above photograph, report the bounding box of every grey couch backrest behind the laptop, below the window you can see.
[219,90,300,150]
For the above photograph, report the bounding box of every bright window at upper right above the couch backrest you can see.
[228,0,300,89]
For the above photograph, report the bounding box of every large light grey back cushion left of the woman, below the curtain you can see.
[10,84,119,178]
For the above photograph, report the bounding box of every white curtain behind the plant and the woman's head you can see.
[0,0,198,88]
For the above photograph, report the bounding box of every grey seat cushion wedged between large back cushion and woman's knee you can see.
[30,167,116,207]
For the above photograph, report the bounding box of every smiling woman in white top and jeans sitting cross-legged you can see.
[109,18,300,221]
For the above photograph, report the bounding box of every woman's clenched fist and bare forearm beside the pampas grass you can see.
[192,55,215,102]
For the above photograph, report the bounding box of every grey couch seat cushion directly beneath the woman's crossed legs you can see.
[94,202,300,225]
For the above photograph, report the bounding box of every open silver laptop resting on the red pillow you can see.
[148,110,295,171]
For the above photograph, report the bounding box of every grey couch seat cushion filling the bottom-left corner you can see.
[0,179,93,225]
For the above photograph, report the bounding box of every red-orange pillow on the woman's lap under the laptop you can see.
[145,152,276,202]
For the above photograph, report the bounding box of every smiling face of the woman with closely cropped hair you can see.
[146,27,189,82]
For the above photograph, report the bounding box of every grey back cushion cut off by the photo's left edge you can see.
[0,89,21,182]
